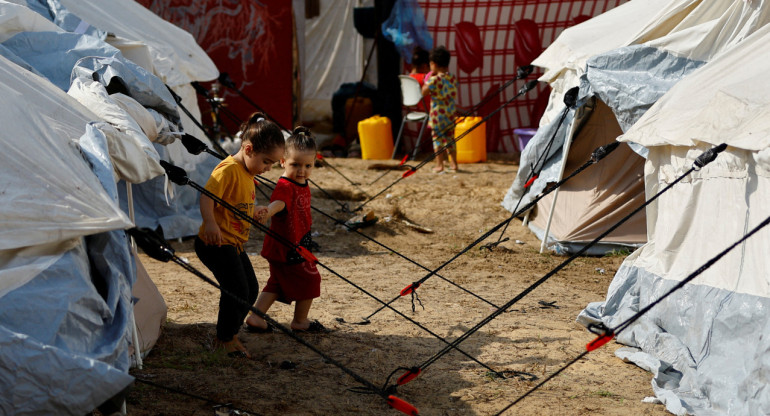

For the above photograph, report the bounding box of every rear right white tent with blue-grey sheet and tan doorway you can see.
[503,0,768,254]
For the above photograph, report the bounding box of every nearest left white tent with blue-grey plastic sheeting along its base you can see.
[0,53,133,415]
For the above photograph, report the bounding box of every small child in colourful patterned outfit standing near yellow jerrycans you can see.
[422,46,457,172]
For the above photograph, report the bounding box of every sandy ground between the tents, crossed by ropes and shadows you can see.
[128,155,667,415]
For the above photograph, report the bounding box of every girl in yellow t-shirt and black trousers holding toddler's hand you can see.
[195,113,284,358]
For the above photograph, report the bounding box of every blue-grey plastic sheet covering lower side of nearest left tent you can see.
[0,125,135,415]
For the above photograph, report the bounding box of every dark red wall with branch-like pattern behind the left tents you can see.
[138,0,294,133]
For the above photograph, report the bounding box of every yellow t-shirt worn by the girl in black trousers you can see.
[198,156,256,249]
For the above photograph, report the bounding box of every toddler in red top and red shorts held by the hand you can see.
[246,127,326,332]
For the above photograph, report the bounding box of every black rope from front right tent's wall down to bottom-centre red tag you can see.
[408,142,727,376]
